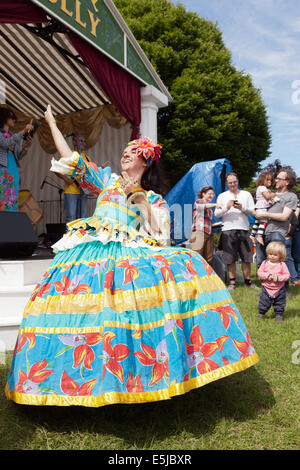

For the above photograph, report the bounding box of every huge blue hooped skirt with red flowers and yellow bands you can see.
[6,241,258,407]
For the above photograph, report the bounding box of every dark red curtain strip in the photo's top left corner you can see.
[0,0,48,24]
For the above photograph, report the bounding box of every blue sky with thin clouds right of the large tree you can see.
[173,0,300,176]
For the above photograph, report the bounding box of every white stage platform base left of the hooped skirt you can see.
[0,248,54,352]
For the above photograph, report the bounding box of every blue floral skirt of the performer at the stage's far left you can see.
[0,152,19,212]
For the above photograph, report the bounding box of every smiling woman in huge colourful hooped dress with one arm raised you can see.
[6,106,258,407]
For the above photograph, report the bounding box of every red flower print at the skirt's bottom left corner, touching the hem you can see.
[15,359,54,395]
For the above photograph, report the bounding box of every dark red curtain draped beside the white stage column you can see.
[68,33,141,139]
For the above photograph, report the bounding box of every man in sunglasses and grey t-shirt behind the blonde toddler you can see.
[255,167,300,285]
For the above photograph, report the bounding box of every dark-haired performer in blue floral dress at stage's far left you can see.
[0,107,33,212]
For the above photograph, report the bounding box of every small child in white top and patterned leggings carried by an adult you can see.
[251,172,279,245]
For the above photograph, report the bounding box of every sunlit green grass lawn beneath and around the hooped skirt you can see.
[0,275,300,450]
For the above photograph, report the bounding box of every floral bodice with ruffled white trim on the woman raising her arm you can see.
[51,152,170,250]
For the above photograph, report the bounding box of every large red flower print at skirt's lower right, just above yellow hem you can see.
[186,325,228,374]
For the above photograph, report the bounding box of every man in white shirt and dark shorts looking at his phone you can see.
[215,173,258,290]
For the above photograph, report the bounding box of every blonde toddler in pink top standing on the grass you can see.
[257,242,290,322]
